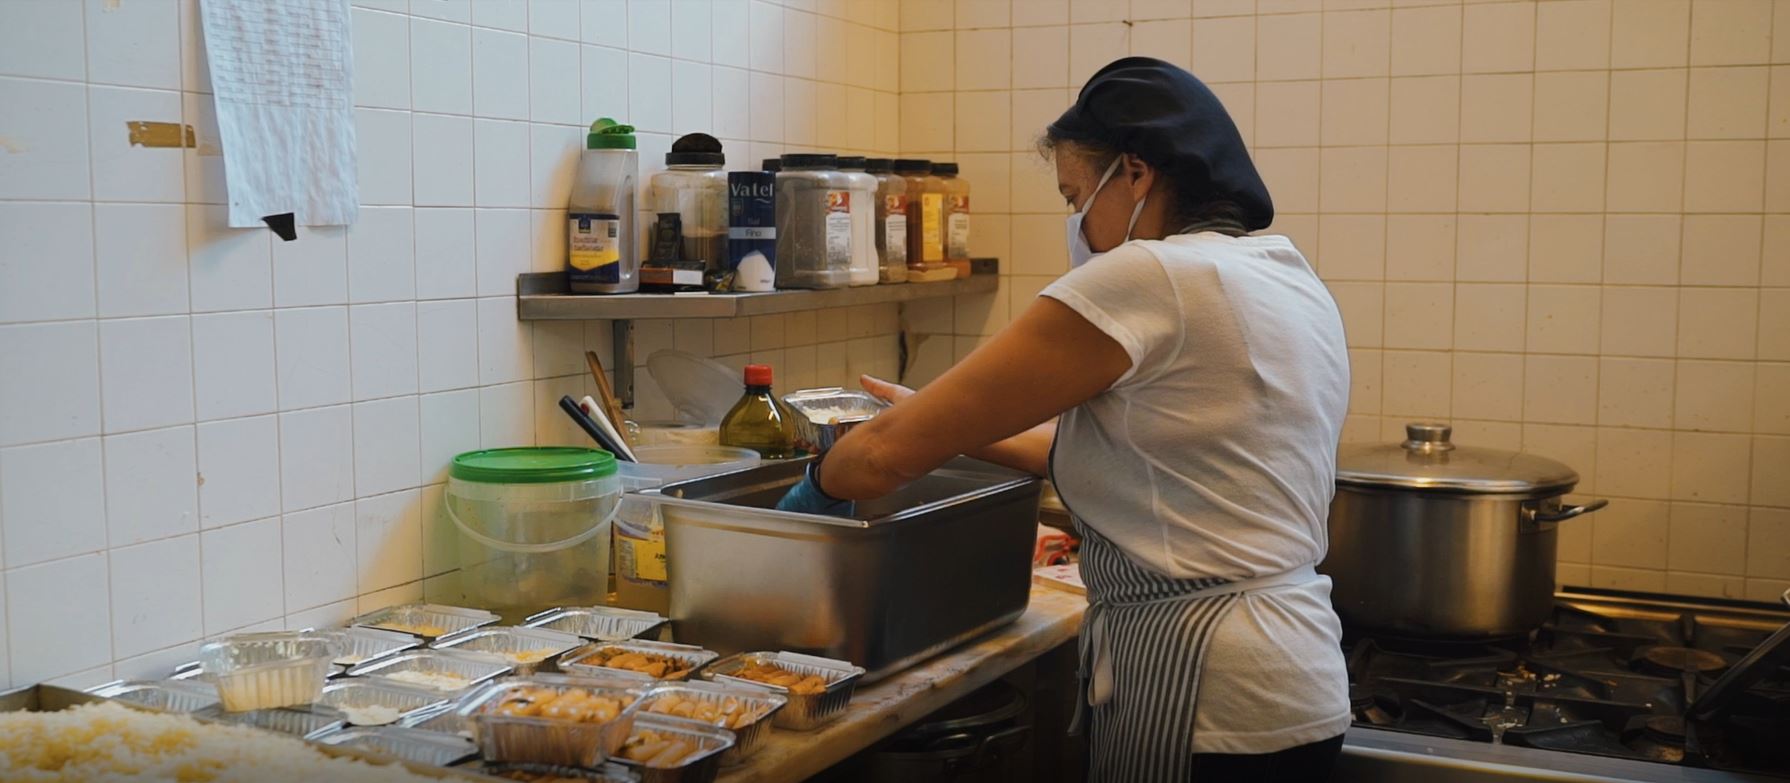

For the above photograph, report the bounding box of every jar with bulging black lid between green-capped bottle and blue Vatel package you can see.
[641,133,727,290]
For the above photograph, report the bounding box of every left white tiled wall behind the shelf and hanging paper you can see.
[0,0,899,684]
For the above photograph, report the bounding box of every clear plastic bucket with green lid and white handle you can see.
[440,446,621,620]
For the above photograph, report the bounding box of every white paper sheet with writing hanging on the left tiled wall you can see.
[199,0,360,228]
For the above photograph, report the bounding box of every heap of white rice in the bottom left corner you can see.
[0,702,435,783]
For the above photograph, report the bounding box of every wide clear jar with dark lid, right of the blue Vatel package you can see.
[777,154,852,288]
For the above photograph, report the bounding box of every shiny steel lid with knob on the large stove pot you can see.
[1337,423,1579,495]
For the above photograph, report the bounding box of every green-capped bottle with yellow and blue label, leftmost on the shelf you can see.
[566,116,641,294]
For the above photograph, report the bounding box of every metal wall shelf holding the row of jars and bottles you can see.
[516,266,1001,321]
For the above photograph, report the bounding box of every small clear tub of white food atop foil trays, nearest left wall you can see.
[199,632,342,713]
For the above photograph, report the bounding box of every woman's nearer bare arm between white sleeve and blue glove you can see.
[822,297,1131,500]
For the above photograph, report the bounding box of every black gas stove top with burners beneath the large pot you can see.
[1344,591,1790,779]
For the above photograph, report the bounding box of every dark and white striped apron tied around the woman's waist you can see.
[1076,518,1317,783]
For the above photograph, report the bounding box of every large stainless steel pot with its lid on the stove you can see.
[1317,425,1607,638]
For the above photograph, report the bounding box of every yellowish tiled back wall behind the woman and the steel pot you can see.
[900,0,1790,600]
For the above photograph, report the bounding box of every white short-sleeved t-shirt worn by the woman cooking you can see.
[1042,233,1350,753]
